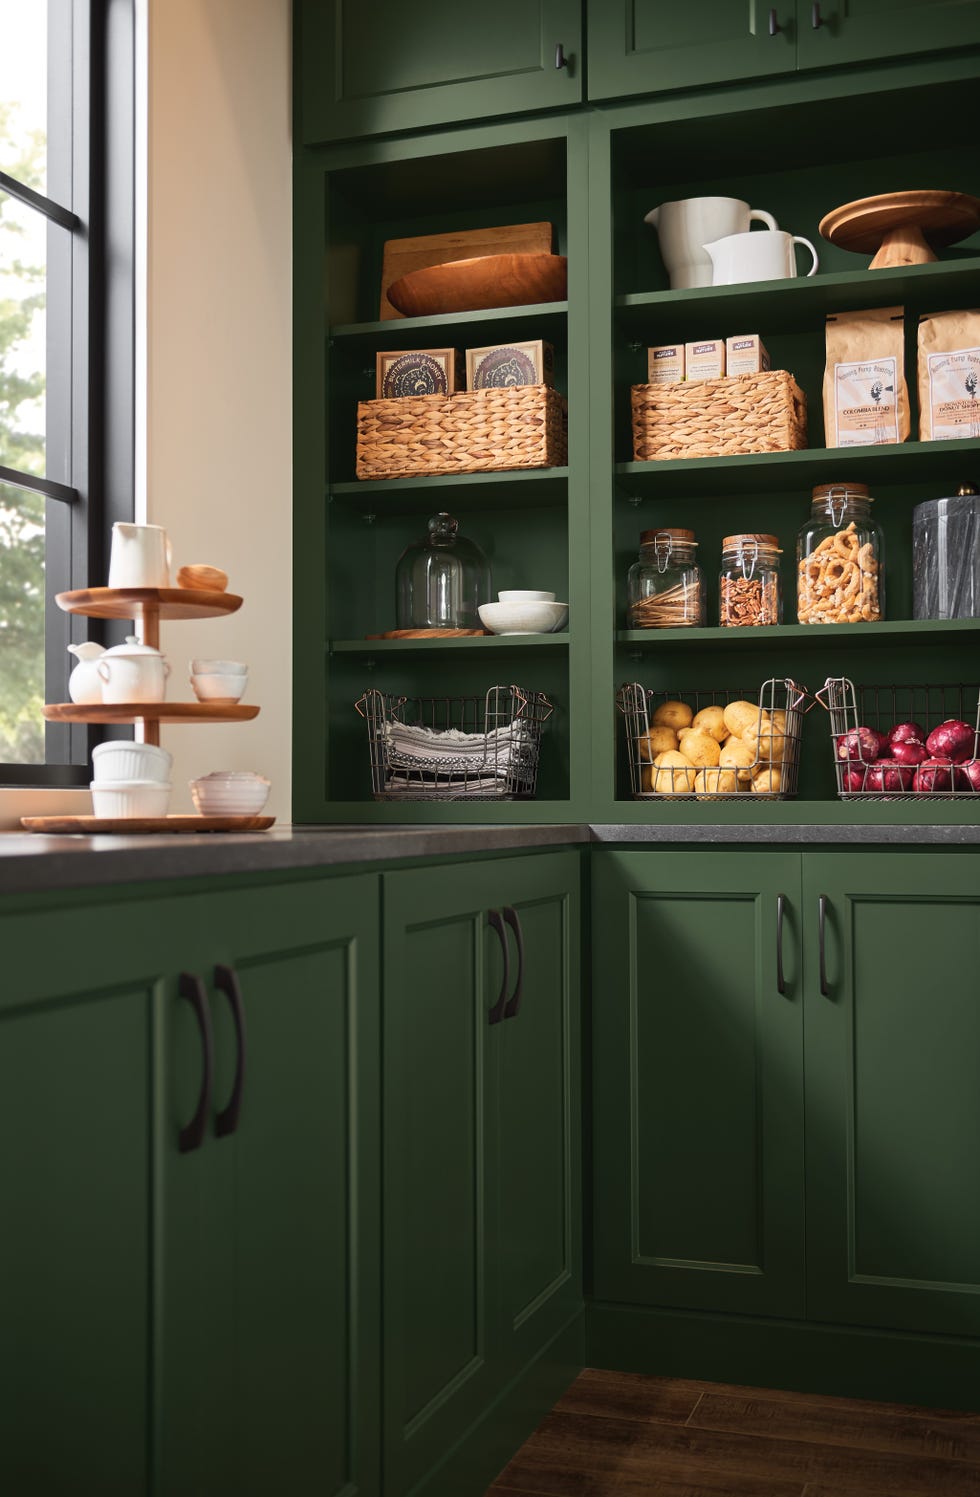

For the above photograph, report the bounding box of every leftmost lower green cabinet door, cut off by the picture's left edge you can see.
[0,900,202,1497]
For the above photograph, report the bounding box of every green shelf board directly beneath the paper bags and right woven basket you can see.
[616,437,980,499]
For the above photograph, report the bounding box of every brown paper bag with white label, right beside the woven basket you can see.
[823,307,911,448]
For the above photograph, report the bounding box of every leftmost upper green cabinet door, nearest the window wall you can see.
[296,0,582,145]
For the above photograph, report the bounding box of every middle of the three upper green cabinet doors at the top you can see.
[588,0,796,99]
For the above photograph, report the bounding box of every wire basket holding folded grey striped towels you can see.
[355,686,554,801]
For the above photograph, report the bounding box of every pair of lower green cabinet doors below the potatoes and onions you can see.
[592,849,980,1337]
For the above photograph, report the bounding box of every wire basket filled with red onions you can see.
[814,675,980,801]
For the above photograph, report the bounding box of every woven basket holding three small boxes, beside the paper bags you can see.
[630,370,806,463]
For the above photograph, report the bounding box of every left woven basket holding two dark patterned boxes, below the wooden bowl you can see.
[356,385,569,478]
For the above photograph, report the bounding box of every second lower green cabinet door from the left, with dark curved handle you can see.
[171,876,380,1497]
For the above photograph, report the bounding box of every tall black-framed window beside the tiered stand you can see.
[0,0,133,784]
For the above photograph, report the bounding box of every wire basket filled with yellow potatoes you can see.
[616,678,806,801]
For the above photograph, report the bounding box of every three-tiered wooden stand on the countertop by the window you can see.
[21,587,275,834]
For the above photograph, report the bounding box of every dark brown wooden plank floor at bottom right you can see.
[488,1370,980,1497]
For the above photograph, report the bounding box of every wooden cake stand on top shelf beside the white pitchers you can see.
[820,192,980,271]
